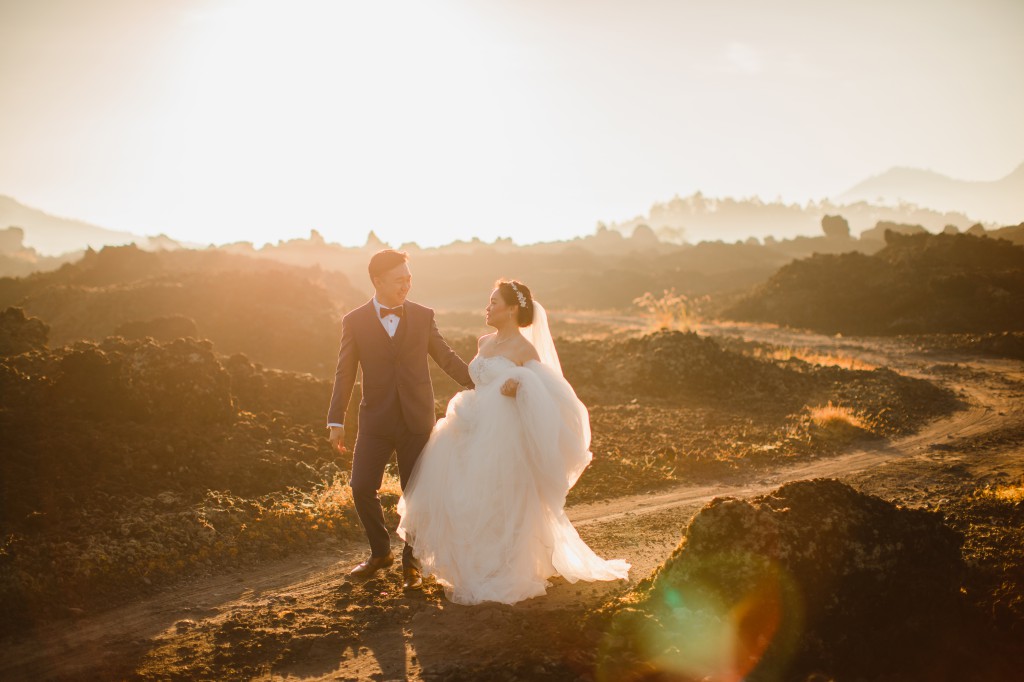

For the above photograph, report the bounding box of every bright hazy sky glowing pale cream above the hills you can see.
[0,0,1024,246]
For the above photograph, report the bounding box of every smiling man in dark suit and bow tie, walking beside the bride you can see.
[327,249,473,590]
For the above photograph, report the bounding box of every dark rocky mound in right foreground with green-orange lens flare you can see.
[602,479,998,680]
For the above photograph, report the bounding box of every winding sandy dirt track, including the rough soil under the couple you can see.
[0,326,1024,680]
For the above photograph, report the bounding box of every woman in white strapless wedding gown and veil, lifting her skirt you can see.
[398,281,630,604]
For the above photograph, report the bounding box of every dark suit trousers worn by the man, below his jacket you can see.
[350,420,430,565]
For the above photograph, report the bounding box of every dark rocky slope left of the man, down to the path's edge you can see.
[0,338,357,630]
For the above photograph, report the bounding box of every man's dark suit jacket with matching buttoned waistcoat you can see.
[327,299,473,434]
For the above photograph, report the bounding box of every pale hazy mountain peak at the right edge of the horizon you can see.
[836,164,1024,224]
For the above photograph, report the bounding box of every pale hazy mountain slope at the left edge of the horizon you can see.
[0,196,167,256]
